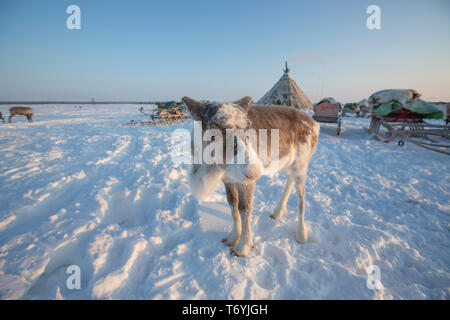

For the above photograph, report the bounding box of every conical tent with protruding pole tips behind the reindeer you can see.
[256,63,312,110]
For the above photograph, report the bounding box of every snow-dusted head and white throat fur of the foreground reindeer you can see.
[183,97,262,198]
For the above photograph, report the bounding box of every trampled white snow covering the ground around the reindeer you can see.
[0,105,450,299]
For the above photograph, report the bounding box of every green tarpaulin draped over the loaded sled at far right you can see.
[375,99,444,119]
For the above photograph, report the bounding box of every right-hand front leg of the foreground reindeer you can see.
[231,182,256,257]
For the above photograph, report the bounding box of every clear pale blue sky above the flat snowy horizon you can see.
[0,0,450,102]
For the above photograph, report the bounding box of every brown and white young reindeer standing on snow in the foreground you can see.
[182,97,320,257]
